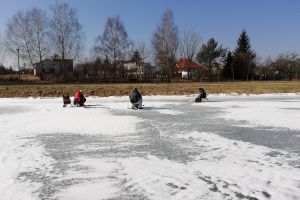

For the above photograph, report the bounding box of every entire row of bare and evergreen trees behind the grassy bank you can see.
[0,3,300,82]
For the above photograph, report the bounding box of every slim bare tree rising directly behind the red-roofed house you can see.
[180,31,200,80]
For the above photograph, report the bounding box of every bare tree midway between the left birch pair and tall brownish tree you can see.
[94,16,132,81]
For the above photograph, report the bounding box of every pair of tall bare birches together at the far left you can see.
[5,3,84,80]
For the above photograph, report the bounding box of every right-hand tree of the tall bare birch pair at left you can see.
[49,3,84,81]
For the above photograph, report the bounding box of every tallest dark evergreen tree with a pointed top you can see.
[233,30,256,80]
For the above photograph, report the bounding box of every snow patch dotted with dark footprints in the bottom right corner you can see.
[177,132,300,199]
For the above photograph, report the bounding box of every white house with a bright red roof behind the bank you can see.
[176,59,206,79]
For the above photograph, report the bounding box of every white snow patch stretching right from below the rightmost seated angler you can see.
[194,99,300,130]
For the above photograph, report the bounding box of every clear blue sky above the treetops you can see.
[0,0,300,67]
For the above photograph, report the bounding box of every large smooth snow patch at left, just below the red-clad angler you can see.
[0,99,141,135]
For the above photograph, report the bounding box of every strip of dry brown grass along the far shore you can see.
[0,81,300,98]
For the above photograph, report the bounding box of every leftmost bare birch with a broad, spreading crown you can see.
[6,8,49,79]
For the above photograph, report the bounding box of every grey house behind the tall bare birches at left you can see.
[34,55,73,76]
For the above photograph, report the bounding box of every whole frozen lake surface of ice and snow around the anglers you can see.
[0,94,300,200]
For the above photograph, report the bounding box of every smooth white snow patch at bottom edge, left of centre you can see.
[56,158,120,200]
